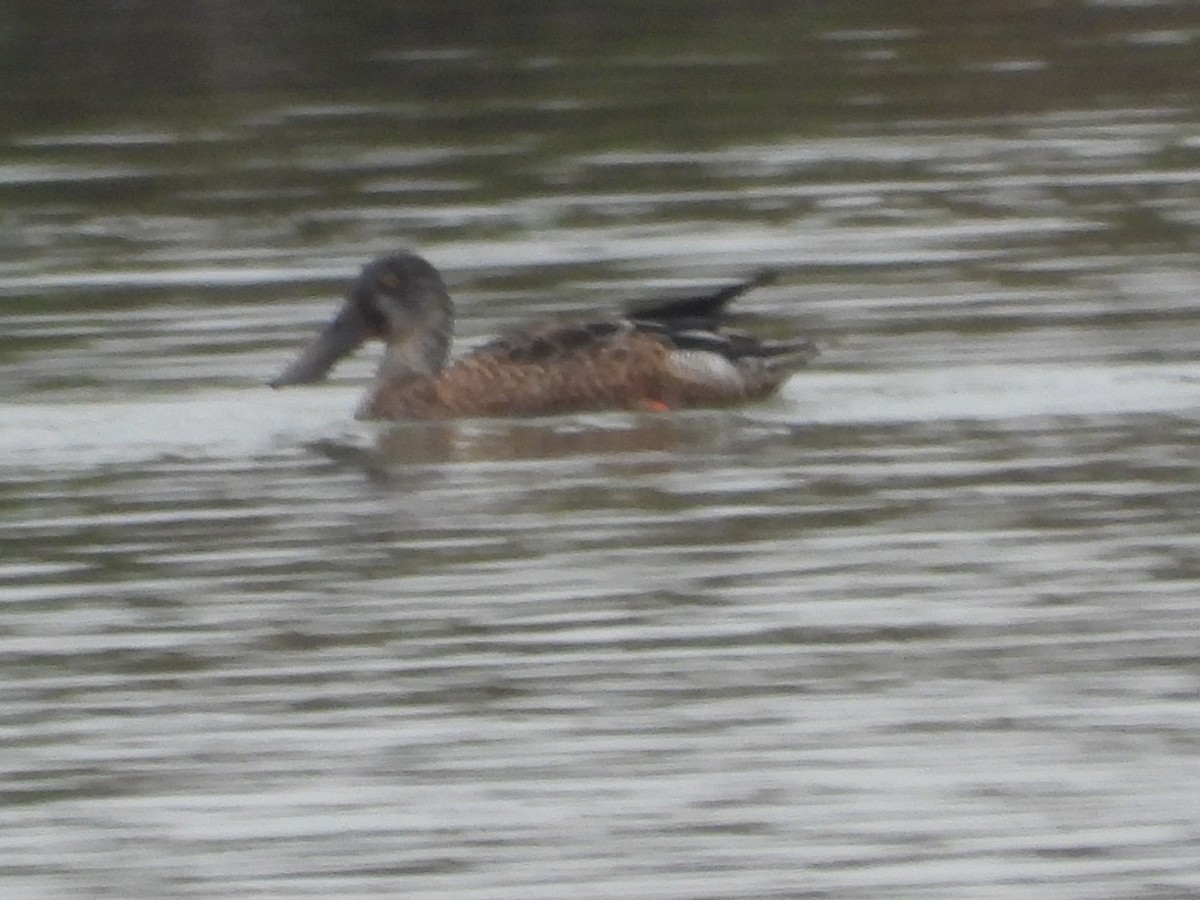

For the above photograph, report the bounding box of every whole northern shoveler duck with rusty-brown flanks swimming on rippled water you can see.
[271,251,816,419]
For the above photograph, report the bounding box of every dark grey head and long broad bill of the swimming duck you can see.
[271,251,454,388]
